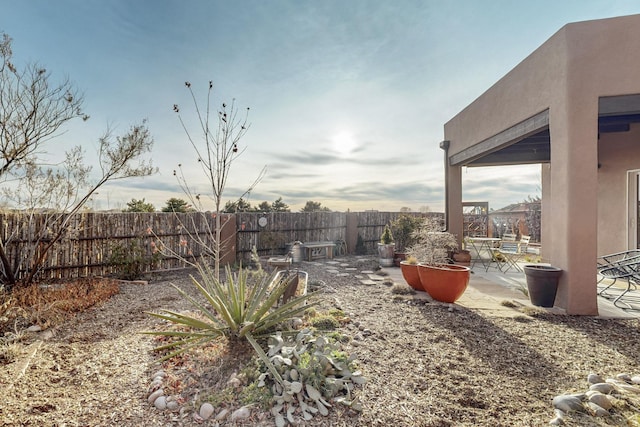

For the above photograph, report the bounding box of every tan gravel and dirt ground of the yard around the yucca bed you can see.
[0,257,640,427]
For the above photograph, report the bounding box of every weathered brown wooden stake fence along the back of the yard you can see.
[0,211,440,279]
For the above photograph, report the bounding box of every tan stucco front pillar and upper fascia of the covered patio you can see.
[444,15,640,314]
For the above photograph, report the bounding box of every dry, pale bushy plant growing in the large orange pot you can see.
[407,218,458,265]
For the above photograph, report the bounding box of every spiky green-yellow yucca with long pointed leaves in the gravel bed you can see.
[144,264,318,378]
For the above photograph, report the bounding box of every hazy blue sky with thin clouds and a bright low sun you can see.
[0,0,640,212]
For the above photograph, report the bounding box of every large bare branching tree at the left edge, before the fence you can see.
[0,34,155,290]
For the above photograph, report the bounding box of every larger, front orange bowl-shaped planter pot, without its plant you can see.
[418,264,471,303]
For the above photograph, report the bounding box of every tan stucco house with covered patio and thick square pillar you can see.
[440,15,640,315]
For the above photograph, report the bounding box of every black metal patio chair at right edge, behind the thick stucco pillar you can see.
[598,256,640,310]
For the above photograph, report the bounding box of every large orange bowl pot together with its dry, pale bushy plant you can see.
[408,218,471,303]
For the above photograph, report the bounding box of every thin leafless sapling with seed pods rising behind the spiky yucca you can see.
[173,81,266,277]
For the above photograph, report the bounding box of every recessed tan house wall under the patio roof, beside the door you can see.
[598,123,640,255]
